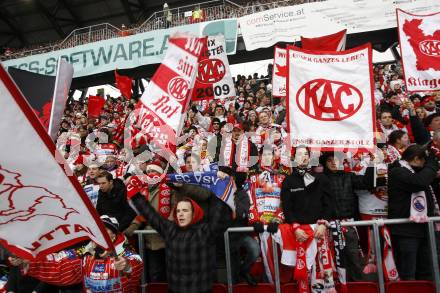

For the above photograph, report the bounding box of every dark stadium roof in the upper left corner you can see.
[0,0,194,48]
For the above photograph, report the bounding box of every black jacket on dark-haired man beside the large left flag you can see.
[96,179,136,232]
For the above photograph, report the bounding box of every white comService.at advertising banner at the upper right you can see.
[239,0,440,51]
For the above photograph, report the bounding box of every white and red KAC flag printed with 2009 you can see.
[192,35,235,101]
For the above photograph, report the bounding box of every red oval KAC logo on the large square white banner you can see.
[296,79,364,121]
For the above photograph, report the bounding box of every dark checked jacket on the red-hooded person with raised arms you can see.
[131,185,232,293]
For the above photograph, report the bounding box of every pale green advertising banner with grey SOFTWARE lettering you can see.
[3,19,237,77]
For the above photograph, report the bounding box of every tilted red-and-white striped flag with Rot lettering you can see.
[131,35,206,150]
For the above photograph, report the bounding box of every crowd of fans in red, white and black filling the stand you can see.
[0,63,440,292]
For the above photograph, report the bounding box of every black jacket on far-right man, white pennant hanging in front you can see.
[388,160,438,238]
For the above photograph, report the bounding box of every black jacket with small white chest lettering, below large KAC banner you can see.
[281,170,334,224]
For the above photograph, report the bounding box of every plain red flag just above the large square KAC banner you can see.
[301,29,347,51]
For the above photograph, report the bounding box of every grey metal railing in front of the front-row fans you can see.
[134,217,440,293]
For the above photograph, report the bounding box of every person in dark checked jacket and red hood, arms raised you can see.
[127,176,232,293]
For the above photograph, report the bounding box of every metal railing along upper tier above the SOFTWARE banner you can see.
[0,0,325,60]
